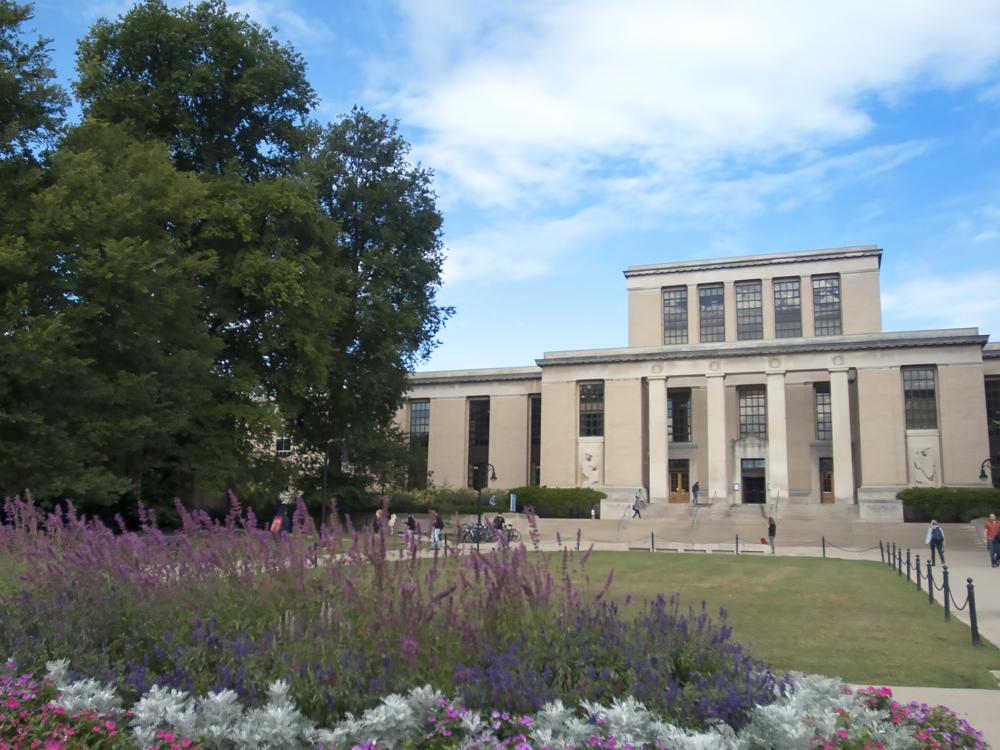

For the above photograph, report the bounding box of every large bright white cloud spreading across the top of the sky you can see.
[380,0,1000,209]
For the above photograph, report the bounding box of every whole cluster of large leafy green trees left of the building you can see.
[0,0,450,506]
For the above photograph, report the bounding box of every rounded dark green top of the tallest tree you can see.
[75,0,316,178]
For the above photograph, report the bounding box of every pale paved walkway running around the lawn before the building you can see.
[452,520,1000,749]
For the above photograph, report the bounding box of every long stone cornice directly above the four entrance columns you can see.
[535,328,988,367]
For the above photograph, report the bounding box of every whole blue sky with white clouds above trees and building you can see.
[25,0,1000,370]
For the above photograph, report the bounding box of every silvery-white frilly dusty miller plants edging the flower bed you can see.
[39,660,932,750]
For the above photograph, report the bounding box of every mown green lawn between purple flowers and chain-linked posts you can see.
[586,552,1000,688]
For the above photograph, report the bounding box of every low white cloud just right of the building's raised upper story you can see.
[882,270,1000,336]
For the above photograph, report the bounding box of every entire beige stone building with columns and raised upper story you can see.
[398,246,1000,520]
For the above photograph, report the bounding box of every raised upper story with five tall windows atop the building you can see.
[625,250,882,347]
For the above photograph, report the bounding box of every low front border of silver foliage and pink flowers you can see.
[0,662,988,750]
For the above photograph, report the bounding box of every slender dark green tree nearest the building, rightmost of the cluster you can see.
[289,109,451,500]
